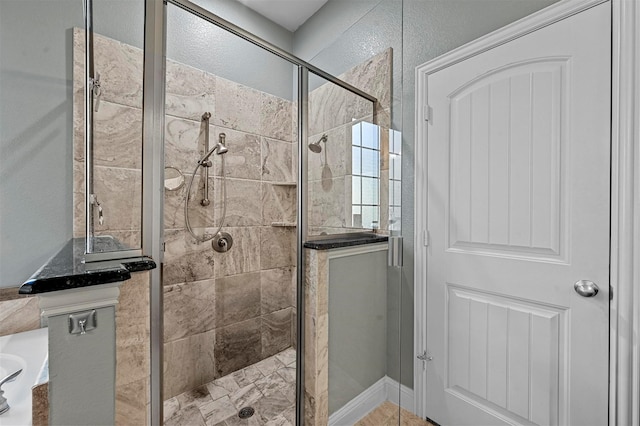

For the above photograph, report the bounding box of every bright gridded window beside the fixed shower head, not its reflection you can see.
[351,121,380,228]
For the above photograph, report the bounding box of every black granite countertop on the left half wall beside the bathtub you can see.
[19,237,156,294]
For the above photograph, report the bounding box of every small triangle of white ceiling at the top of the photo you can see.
[238,0,327,32]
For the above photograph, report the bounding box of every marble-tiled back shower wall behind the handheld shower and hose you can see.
[164,45,297,399]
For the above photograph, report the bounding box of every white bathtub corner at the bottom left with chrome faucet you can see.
[0,328,49,426]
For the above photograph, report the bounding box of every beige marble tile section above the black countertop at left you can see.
[73,28,143,248]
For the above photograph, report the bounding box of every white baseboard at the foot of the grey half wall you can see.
[329,376,414,426]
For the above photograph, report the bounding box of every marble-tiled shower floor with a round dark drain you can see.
[164,348,296,426]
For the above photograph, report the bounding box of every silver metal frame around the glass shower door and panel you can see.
[142,0,378,425]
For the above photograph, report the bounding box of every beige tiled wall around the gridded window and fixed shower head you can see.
[308,48,392,240]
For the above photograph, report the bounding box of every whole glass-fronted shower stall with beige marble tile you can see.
[73,0,402,425]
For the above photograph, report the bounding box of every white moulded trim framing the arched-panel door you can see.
[413,0,640,425]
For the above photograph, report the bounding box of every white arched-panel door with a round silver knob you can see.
[418,3,611,426]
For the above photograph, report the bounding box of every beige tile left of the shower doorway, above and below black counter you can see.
[73,29,149,425]
